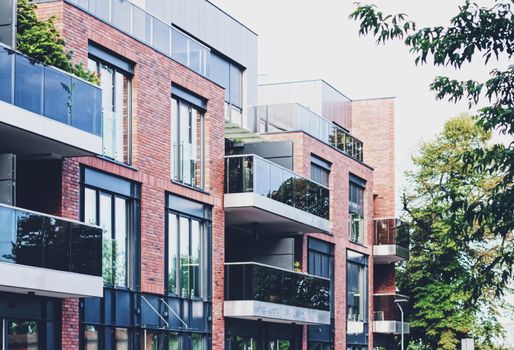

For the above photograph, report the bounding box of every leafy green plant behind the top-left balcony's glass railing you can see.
[16,0,100,85]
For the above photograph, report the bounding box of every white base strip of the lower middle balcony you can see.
[224,300,330,325]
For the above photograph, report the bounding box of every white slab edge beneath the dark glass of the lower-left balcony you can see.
[0,262,103,298]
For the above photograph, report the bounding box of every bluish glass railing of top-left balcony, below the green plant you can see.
[0,45,102,136]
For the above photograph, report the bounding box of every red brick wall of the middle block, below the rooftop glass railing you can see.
[264,132,374,350]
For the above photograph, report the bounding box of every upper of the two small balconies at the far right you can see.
[373,218,409,264]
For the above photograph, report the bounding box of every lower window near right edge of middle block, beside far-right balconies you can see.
[346,250,368,322]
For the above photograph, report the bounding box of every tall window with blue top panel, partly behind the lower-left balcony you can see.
[83,169,135,288]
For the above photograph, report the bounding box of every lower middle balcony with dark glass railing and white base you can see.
[224,262,330,325]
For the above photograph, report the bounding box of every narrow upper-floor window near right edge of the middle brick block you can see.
[348,175,365,244]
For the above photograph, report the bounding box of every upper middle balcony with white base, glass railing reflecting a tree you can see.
[225,155,330,233]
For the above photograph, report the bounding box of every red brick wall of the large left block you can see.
[39,1,224,350]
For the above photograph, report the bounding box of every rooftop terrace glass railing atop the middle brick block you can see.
[248,103,363,162]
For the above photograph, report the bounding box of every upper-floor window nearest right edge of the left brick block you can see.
[171,98,205,188]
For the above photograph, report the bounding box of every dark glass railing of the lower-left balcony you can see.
[0,204,102,276]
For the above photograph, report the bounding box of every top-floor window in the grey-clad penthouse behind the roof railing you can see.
[209,53,243,127]
